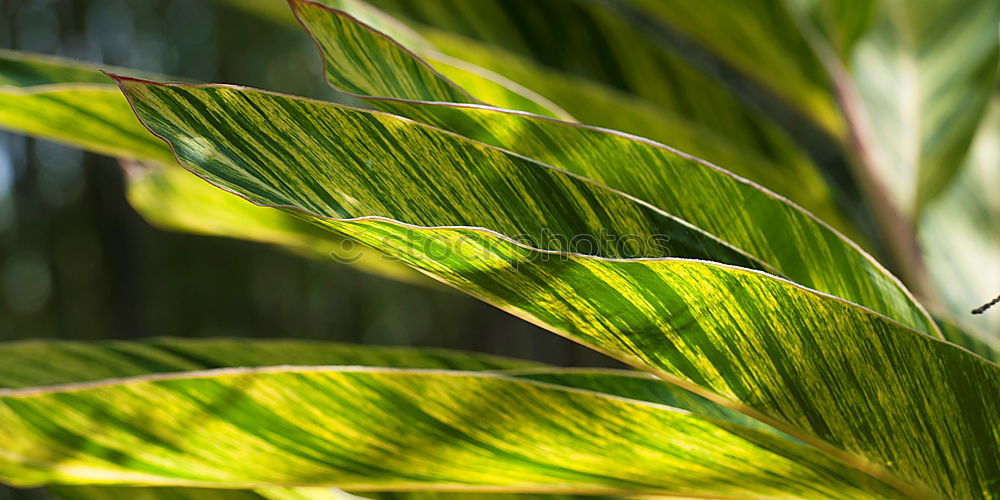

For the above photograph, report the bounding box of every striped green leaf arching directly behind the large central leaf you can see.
[288,3,936,334]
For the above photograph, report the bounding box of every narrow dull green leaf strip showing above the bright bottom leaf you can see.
[7,339,880,499]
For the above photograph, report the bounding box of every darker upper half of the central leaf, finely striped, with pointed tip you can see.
[111,77,768,268]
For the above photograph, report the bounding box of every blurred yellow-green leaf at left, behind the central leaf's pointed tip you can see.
[0,50,433,286]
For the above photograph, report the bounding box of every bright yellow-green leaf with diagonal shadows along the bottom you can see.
[0,367,908,498]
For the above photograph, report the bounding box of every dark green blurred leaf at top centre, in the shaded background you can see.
[350,0,836,146]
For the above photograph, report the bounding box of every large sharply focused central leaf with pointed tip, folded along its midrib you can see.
[113,79,1000,497]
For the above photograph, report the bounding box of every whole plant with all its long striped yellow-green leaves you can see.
[0,0,1000,499]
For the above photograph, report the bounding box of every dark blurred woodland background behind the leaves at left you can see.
[0,0,610,368]
